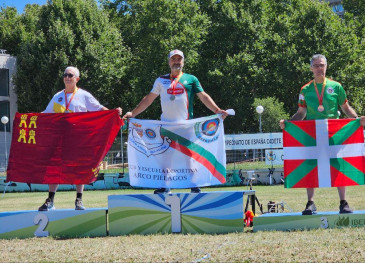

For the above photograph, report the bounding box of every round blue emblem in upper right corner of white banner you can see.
[194,118,220,143]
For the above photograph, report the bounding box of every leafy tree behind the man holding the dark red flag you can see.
[15,0,130,112]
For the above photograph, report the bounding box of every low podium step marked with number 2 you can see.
[0,208,107,238]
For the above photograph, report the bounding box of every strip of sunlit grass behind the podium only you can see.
[0,185,365,212]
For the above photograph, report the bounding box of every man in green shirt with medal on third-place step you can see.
[280,54,365,215]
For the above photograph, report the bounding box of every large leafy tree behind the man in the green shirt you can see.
[195,0,360,132]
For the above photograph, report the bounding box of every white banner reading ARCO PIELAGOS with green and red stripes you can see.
[128,115,226,188]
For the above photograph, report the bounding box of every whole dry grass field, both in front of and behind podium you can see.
[0,186,365,262]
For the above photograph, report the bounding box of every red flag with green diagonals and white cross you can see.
[283,119,365,188]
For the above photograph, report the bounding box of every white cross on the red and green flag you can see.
[284,120,365,187]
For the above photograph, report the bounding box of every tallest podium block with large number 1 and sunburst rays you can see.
[108,191,255,236]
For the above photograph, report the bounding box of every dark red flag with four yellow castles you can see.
[7,110,123,184]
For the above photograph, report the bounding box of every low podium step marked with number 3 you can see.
[253,211,365,232]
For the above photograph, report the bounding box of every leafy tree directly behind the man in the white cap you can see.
[104,0,209,119]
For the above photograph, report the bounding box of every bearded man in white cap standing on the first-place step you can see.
[123,49,228,193]
